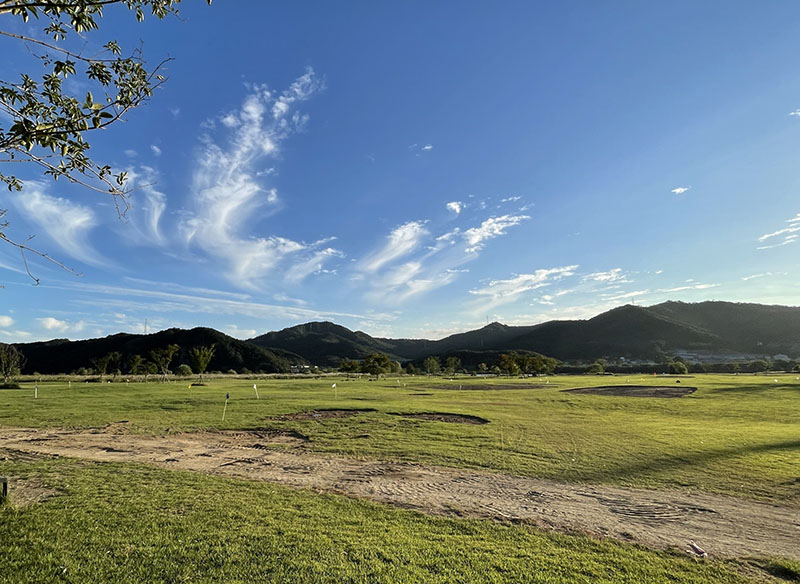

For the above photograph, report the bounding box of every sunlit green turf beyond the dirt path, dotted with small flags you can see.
[0,375,800,507]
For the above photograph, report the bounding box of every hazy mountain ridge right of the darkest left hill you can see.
[250,301,800,365]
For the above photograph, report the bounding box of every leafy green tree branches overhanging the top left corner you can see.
[0,0,211,274]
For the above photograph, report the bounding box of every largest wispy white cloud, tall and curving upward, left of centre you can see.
[180,69,332,287]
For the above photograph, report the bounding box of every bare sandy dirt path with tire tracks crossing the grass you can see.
[0,426,800,560]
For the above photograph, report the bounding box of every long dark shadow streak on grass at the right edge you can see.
[581,440,800,483]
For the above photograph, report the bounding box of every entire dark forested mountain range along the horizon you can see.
[16,301,800,373]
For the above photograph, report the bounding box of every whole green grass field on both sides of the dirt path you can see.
[0,375,800,582]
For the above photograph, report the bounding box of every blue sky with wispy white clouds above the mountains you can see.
[0,0,800,342]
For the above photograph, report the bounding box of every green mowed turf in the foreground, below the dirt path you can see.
[0,456,800,584]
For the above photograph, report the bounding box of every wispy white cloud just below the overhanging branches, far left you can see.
[14,181,106,266]
